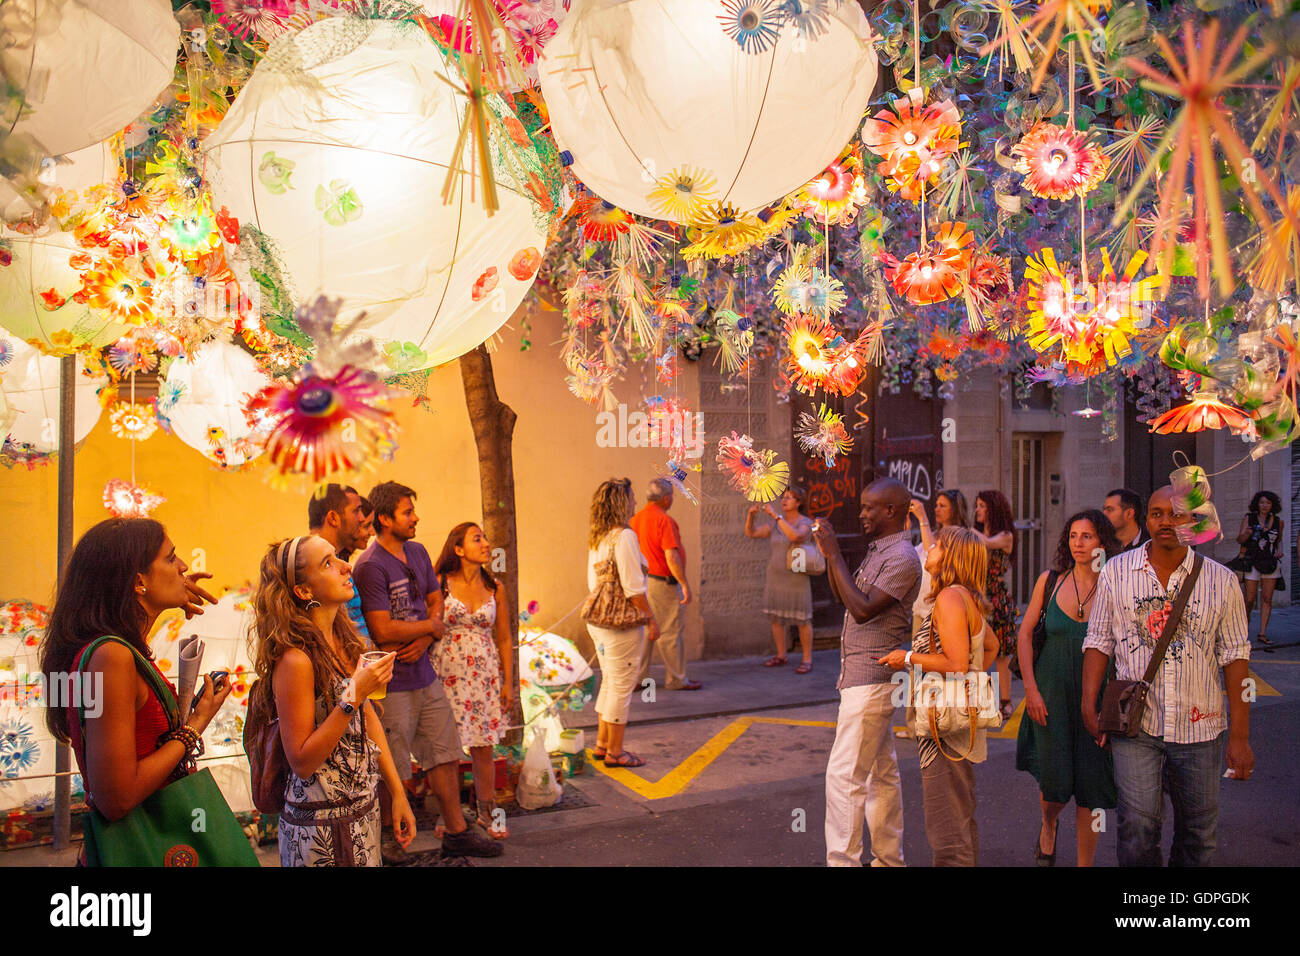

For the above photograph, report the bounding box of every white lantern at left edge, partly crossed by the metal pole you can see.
[0,336,100,455]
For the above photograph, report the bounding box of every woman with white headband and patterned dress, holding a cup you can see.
[252,535,415,866]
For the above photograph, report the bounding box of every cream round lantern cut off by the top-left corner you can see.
[0,0,181,156]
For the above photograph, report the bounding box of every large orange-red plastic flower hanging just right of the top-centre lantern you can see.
[862,87,962,203]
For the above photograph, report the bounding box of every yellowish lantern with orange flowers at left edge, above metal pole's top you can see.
[0,233,126,355]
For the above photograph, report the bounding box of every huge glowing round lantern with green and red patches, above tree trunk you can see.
[205,18,553,368]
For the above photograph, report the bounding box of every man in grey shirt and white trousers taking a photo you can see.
[813,479,920,866]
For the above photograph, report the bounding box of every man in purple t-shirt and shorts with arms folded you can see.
[352,481,502,862]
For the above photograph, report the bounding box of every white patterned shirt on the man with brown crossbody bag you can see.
[1083,542,1251,744]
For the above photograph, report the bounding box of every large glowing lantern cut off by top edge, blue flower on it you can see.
[538,0,876,222]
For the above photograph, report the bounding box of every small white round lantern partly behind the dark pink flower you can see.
[159,339,270,468]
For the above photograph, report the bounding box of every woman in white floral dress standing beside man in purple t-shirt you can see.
[433,522,519,840]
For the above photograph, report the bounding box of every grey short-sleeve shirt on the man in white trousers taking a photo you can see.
[836,531,920,691]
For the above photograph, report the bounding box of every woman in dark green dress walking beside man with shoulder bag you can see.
[1015,510,1121,866]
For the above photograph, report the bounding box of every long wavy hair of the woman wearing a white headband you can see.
[248,535,365,696]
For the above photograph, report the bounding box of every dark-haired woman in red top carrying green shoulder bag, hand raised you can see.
[40,518,257,866]
